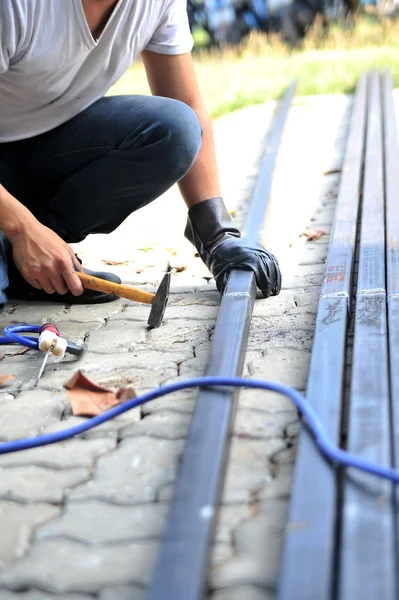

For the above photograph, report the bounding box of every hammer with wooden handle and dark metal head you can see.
[76,271,171,329]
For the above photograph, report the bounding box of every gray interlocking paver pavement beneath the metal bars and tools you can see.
[0,91,352,600]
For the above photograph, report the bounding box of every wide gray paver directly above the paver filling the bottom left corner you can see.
[35,500,168,546]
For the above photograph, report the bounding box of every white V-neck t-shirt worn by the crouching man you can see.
[0,0,193,143]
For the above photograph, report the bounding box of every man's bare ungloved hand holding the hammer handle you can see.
[10,221,83,296]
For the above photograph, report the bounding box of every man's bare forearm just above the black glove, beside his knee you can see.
[179,107,221,207]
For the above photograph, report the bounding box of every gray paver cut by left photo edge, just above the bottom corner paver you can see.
[0,500,61,568]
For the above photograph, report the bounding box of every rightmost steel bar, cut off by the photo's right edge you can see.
[383,73,399,576]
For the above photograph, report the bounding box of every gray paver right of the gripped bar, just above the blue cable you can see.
[247,347,310,390]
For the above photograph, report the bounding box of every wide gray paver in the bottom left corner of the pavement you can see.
[0,540,156,594]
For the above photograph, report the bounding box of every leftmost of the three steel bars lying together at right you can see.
[278,76,367,600]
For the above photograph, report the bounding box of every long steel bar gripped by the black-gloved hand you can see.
[147,86,293,600]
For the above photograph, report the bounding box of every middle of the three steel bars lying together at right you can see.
[338,72,397,600]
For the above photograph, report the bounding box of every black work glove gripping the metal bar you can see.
[184,198,281,298]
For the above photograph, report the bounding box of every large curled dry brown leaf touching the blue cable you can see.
[64,371,135,417]
